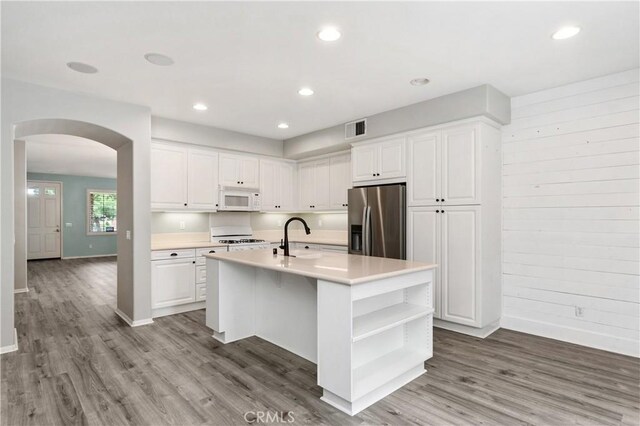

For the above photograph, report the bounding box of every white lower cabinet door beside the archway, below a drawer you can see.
[151,253,196,309]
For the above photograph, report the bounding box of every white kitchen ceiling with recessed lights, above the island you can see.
[2,2,639,139]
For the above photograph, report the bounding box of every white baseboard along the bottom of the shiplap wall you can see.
[500,316,640,358]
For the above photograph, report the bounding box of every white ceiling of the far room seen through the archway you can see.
[26,135,117,178]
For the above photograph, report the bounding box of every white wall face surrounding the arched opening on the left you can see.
[0,79,151,348]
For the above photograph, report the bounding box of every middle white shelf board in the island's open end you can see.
[353,303,433,342]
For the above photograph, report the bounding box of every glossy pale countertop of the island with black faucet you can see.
[204,249,437,285]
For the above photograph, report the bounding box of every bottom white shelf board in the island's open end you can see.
[353,347,428,399]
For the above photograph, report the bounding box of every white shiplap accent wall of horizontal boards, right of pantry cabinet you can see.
[501,69,640,356]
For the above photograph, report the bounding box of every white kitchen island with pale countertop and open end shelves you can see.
[205,250,436,415]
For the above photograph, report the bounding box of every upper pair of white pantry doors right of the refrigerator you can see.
[407,124,480,206]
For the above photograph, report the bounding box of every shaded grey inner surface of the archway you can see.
[14,119,140,325]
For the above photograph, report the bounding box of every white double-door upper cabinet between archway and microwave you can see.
[151,142,218,210]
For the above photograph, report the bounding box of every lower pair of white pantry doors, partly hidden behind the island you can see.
[407,206,484,327]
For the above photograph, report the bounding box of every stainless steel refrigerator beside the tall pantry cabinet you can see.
[349,185,407,259]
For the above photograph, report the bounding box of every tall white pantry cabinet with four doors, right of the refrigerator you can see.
[407,118,502,336]
